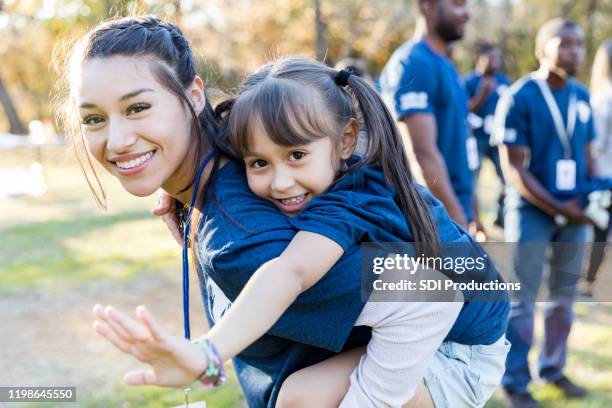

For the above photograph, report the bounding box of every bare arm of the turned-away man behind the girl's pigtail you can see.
[402,113,467,228]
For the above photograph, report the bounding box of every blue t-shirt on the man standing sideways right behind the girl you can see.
[380,41,473,220]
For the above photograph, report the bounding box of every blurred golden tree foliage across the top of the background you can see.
[0,0,612,133]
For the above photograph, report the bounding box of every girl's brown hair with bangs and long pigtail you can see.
[227,57,439,255]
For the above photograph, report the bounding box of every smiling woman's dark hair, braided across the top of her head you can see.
[54,16,233,208]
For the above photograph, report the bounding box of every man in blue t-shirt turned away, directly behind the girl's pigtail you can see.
[380,0,478,228]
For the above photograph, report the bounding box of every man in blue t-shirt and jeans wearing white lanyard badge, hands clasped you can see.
[493,19,594,407]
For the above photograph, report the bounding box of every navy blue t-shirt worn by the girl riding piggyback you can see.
[290,166,509,344]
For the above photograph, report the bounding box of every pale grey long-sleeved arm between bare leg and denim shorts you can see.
[340,302,463,408]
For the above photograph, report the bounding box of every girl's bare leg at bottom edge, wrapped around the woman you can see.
[276,347,434,408]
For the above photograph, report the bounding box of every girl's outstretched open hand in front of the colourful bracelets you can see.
[93,305,207,387]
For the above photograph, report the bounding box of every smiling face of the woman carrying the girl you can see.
[78,56,193,196]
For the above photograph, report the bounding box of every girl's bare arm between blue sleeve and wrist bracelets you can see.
[207,231,344,361]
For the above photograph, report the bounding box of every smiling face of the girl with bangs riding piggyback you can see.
[244,125,340,216]
